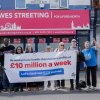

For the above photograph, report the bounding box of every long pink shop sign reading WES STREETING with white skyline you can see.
[0,10,90,36]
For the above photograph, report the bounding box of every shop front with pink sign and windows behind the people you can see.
[0,10,90,52]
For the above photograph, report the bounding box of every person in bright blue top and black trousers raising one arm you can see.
[82,39,100,90]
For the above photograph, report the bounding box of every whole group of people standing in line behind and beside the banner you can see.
[0,38,100,92]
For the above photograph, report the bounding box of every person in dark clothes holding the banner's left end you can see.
[0,38,15,92]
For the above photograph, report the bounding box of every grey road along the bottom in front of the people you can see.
[0,91,100,100]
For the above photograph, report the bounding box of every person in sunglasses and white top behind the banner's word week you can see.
[54,42,66,88]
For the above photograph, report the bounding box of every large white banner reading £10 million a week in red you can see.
[4,51,76,83]
